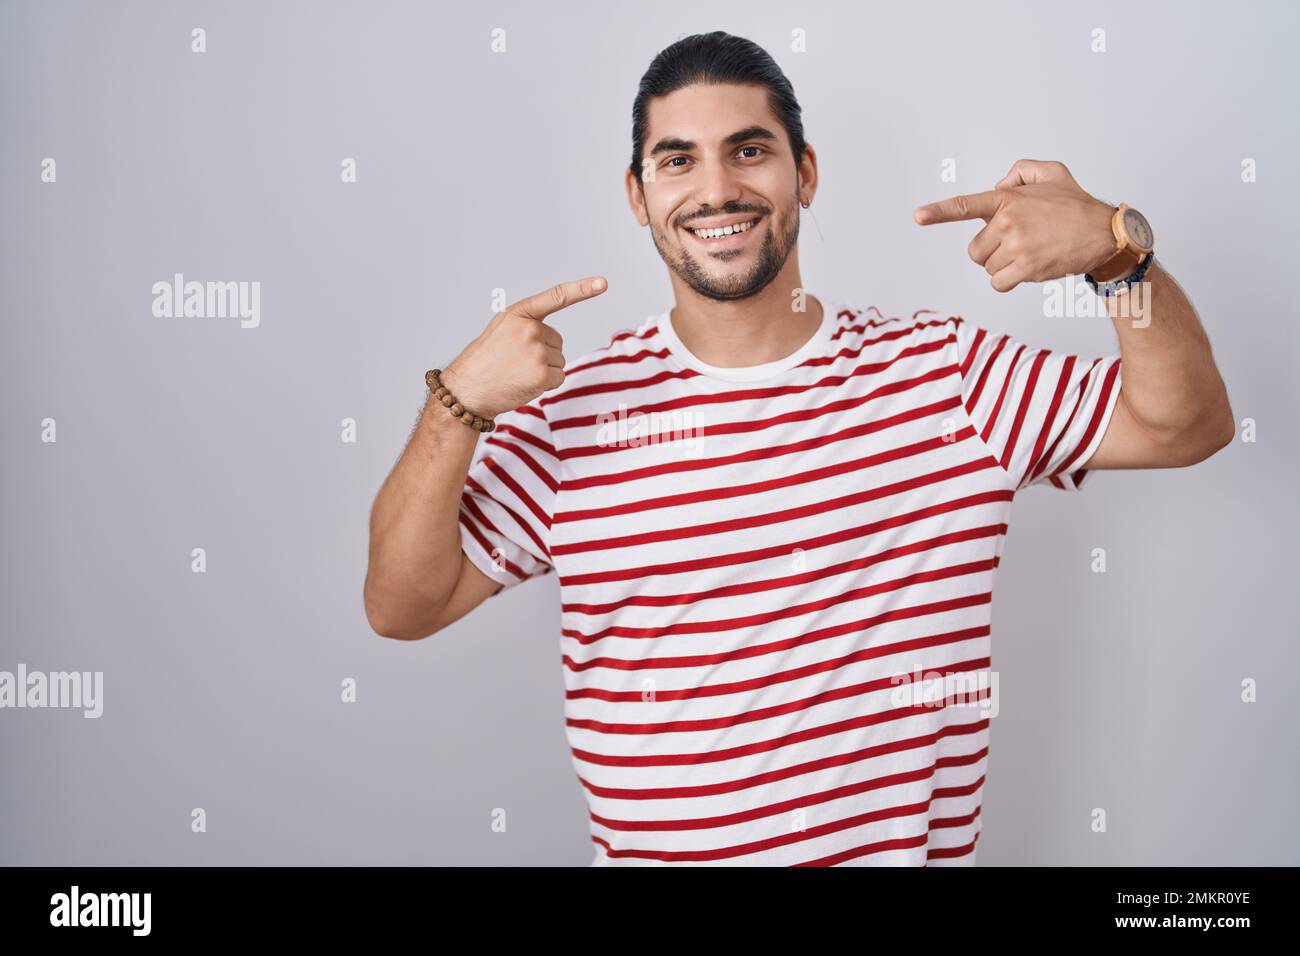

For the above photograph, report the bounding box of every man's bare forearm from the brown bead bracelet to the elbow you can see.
[365,395,480,633]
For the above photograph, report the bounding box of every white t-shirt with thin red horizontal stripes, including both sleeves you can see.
[460,299,1119,866]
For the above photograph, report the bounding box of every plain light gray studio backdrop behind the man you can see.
[0,0,1300,865]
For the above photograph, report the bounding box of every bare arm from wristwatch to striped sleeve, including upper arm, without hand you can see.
[1082,259,1236,471]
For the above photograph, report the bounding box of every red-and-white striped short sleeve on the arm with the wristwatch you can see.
[953,317,1119,490]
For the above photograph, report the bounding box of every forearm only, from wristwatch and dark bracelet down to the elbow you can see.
[1106,259,1236,458]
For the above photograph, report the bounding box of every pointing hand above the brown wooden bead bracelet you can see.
[442,276,608,419]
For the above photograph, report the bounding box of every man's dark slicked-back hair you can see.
[631,30,803,182]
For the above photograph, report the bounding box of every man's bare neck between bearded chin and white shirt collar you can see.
[670,278,824,368]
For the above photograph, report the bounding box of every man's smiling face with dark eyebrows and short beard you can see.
[631,85,800,299]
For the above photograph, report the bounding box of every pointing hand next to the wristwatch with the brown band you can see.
[914,160,1115,293]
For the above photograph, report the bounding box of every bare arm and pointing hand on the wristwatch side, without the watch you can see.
[915,160,1236,470]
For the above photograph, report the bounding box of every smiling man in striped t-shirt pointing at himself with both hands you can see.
[365,33,1235,865]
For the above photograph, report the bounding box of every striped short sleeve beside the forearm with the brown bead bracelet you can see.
[460,405,559,588]
